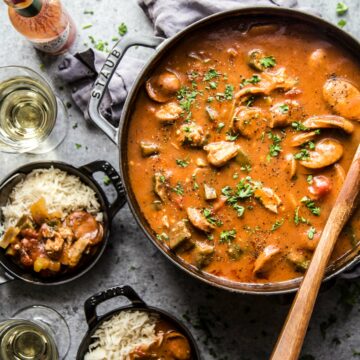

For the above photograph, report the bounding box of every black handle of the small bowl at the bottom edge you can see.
[84,285,146,329]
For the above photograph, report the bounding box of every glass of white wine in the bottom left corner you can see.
[0,305,70,360]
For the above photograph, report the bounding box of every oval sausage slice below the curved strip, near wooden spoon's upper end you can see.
[300,138,344,169]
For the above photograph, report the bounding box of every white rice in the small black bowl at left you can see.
[0,167,101,234]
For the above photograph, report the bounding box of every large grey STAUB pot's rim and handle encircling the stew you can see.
[89,7,360,294]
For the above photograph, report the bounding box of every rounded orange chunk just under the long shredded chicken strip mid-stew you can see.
[232,106,264,138]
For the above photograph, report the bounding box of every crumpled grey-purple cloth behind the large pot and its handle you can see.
[58,0,297,125]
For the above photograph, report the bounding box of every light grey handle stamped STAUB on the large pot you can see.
[88,35,165,144]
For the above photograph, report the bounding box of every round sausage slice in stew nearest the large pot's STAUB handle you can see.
[145,71,181,103]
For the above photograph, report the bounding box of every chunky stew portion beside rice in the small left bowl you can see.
[1,198,104,276]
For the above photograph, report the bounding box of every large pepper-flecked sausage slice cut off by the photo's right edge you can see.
[323,78,360,121]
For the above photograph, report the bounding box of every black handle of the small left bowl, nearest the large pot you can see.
[80,160,126,220]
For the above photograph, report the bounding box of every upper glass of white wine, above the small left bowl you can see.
[0,66,68,154]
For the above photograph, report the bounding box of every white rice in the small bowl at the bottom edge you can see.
[84,311,157,360]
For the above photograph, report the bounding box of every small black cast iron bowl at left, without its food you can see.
[0,160,126,285]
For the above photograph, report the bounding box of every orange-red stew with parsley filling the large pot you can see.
[128,22,360,282]
